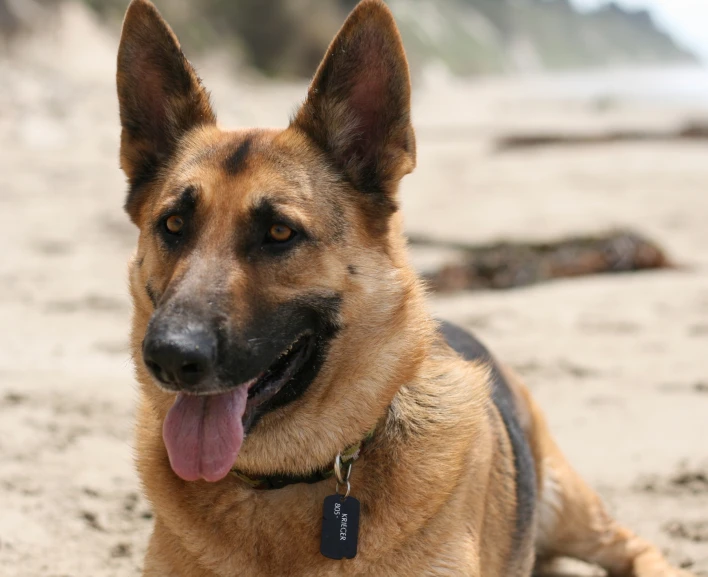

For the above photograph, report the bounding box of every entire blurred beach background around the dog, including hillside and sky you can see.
[0,0,708,577]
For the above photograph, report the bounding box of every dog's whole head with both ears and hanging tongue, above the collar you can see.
[118,0,425,481]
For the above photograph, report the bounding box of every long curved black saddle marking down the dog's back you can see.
[440,322,536,558]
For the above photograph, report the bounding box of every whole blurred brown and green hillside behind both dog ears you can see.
[0,0,695,78]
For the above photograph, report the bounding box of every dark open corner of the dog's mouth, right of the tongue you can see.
[248,334,315,406]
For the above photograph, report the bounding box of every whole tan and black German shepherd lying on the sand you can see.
[118,0,687,577]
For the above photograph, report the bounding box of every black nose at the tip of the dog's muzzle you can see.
[143,327,216,389]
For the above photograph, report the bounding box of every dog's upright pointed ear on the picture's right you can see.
[291,0,415,202]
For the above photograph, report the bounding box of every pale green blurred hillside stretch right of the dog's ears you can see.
[390,0,692,75]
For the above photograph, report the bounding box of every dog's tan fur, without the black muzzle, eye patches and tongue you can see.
[118,0,696,577]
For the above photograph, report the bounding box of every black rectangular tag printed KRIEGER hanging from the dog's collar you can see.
[320,495,361,559]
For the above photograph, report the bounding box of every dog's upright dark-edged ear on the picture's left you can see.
[117,0,216,222]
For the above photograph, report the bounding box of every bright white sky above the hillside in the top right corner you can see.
[572,0,708,62]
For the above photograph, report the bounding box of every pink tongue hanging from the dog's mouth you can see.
[162,385,248,482]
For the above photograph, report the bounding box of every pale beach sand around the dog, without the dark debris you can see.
[0,5,708,577]
